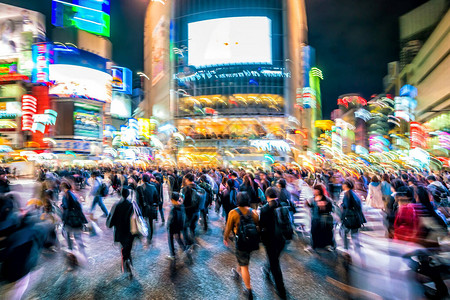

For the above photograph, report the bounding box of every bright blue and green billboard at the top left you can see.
[52,0,110,37]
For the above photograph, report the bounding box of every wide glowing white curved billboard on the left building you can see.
[49,64,112,102]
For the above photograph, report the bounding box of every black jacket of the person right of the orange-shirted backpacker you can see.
[259,201,285,248]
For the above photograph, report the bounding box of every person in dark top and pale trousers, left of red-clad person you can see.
[340,180,366,259]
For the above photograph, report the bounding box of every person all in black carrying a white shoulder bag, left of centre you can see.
[106,188,135,279]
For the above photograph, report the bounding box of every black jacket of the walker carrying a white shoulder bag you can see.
[106,199,133,242]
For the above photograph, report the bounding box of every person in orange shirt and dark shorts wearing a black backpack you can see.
[223,192,260,299]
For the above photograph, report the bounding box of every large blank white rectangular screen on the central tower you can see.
[188,17,272,67]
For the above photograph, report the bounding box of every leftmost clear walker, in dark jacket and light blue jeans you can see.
[61,182,88,258]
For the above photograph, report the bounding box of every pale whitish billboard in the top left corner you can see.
[0,3,45,75]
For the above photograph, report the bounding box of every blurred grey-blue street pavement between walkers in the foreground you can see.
[7,181,348,300]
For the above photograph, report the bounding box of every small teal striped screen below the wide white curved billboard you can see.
[73,103,103,139]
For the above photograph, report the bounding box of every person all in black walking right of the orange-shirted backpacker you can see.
[259,187,292,299]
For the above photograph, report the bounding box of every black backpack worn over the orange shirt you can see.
[235,208,260,252]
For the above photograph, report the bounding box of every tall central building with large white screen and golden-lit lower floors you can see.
[142,0,311,165]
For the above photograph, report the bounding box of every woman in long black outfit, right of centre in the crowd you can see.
[308,184,334,251]
